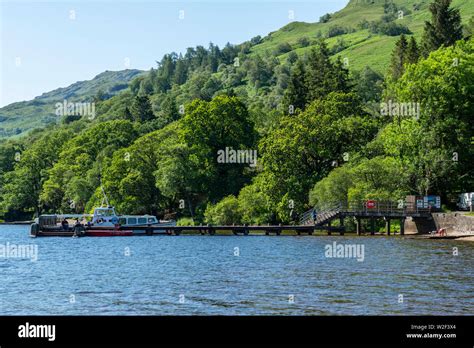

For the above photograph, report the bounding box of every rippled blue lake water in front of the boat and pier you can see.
[0,226,474,315]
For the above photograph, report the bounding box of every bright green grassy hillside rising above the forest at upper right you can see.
[252,0,474,73]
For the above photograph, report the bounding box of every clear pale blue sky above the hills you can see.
[0,0,349,106]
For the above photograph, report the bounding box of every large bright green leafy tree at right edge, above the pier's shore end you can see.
[381,39,474,198]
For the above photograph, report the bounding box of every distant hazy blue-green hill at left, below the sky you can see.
[0,69,143,138]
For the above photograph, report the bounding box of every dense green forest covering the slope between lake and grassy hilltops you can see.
[0,0,474,224]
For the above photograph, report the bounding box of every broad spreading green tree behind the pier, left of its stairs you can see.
[259,92,376,221]
